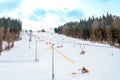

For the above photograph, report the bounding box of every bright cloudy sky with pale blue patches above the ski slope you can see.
[0,0,120,31]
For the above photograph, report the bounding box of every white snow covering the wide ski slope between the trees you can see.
[0,32,120,80]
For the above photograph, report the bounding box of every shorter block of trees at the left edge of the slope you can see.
[0,17,22,55]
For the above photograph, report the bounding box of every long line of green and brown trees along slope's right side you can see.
[54,13,120,47]
